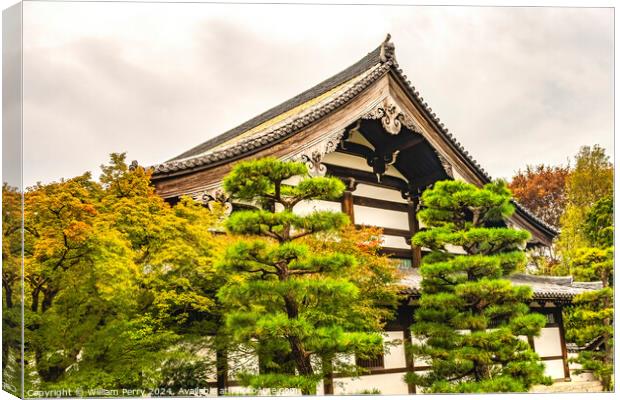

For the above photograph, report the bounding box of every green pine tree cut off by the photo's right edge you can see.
[565,196,614,391]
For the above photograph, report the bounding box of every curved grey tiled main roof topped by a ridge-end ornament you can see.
[152,34,558,236]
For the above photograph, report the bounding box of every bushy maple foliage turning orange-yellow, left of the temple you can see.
[3,154,222,389]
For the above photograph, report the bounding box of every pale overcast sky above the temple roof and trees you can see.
[18,2,613,185]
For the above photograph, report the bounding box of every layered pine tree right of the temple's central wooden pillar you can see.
[407,181,550,393]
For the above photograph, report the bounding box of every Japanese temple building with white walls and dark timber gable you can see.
[152,35,600,394]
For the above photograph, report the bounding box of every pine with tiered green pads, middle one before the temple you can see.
[219,158,393,394]
